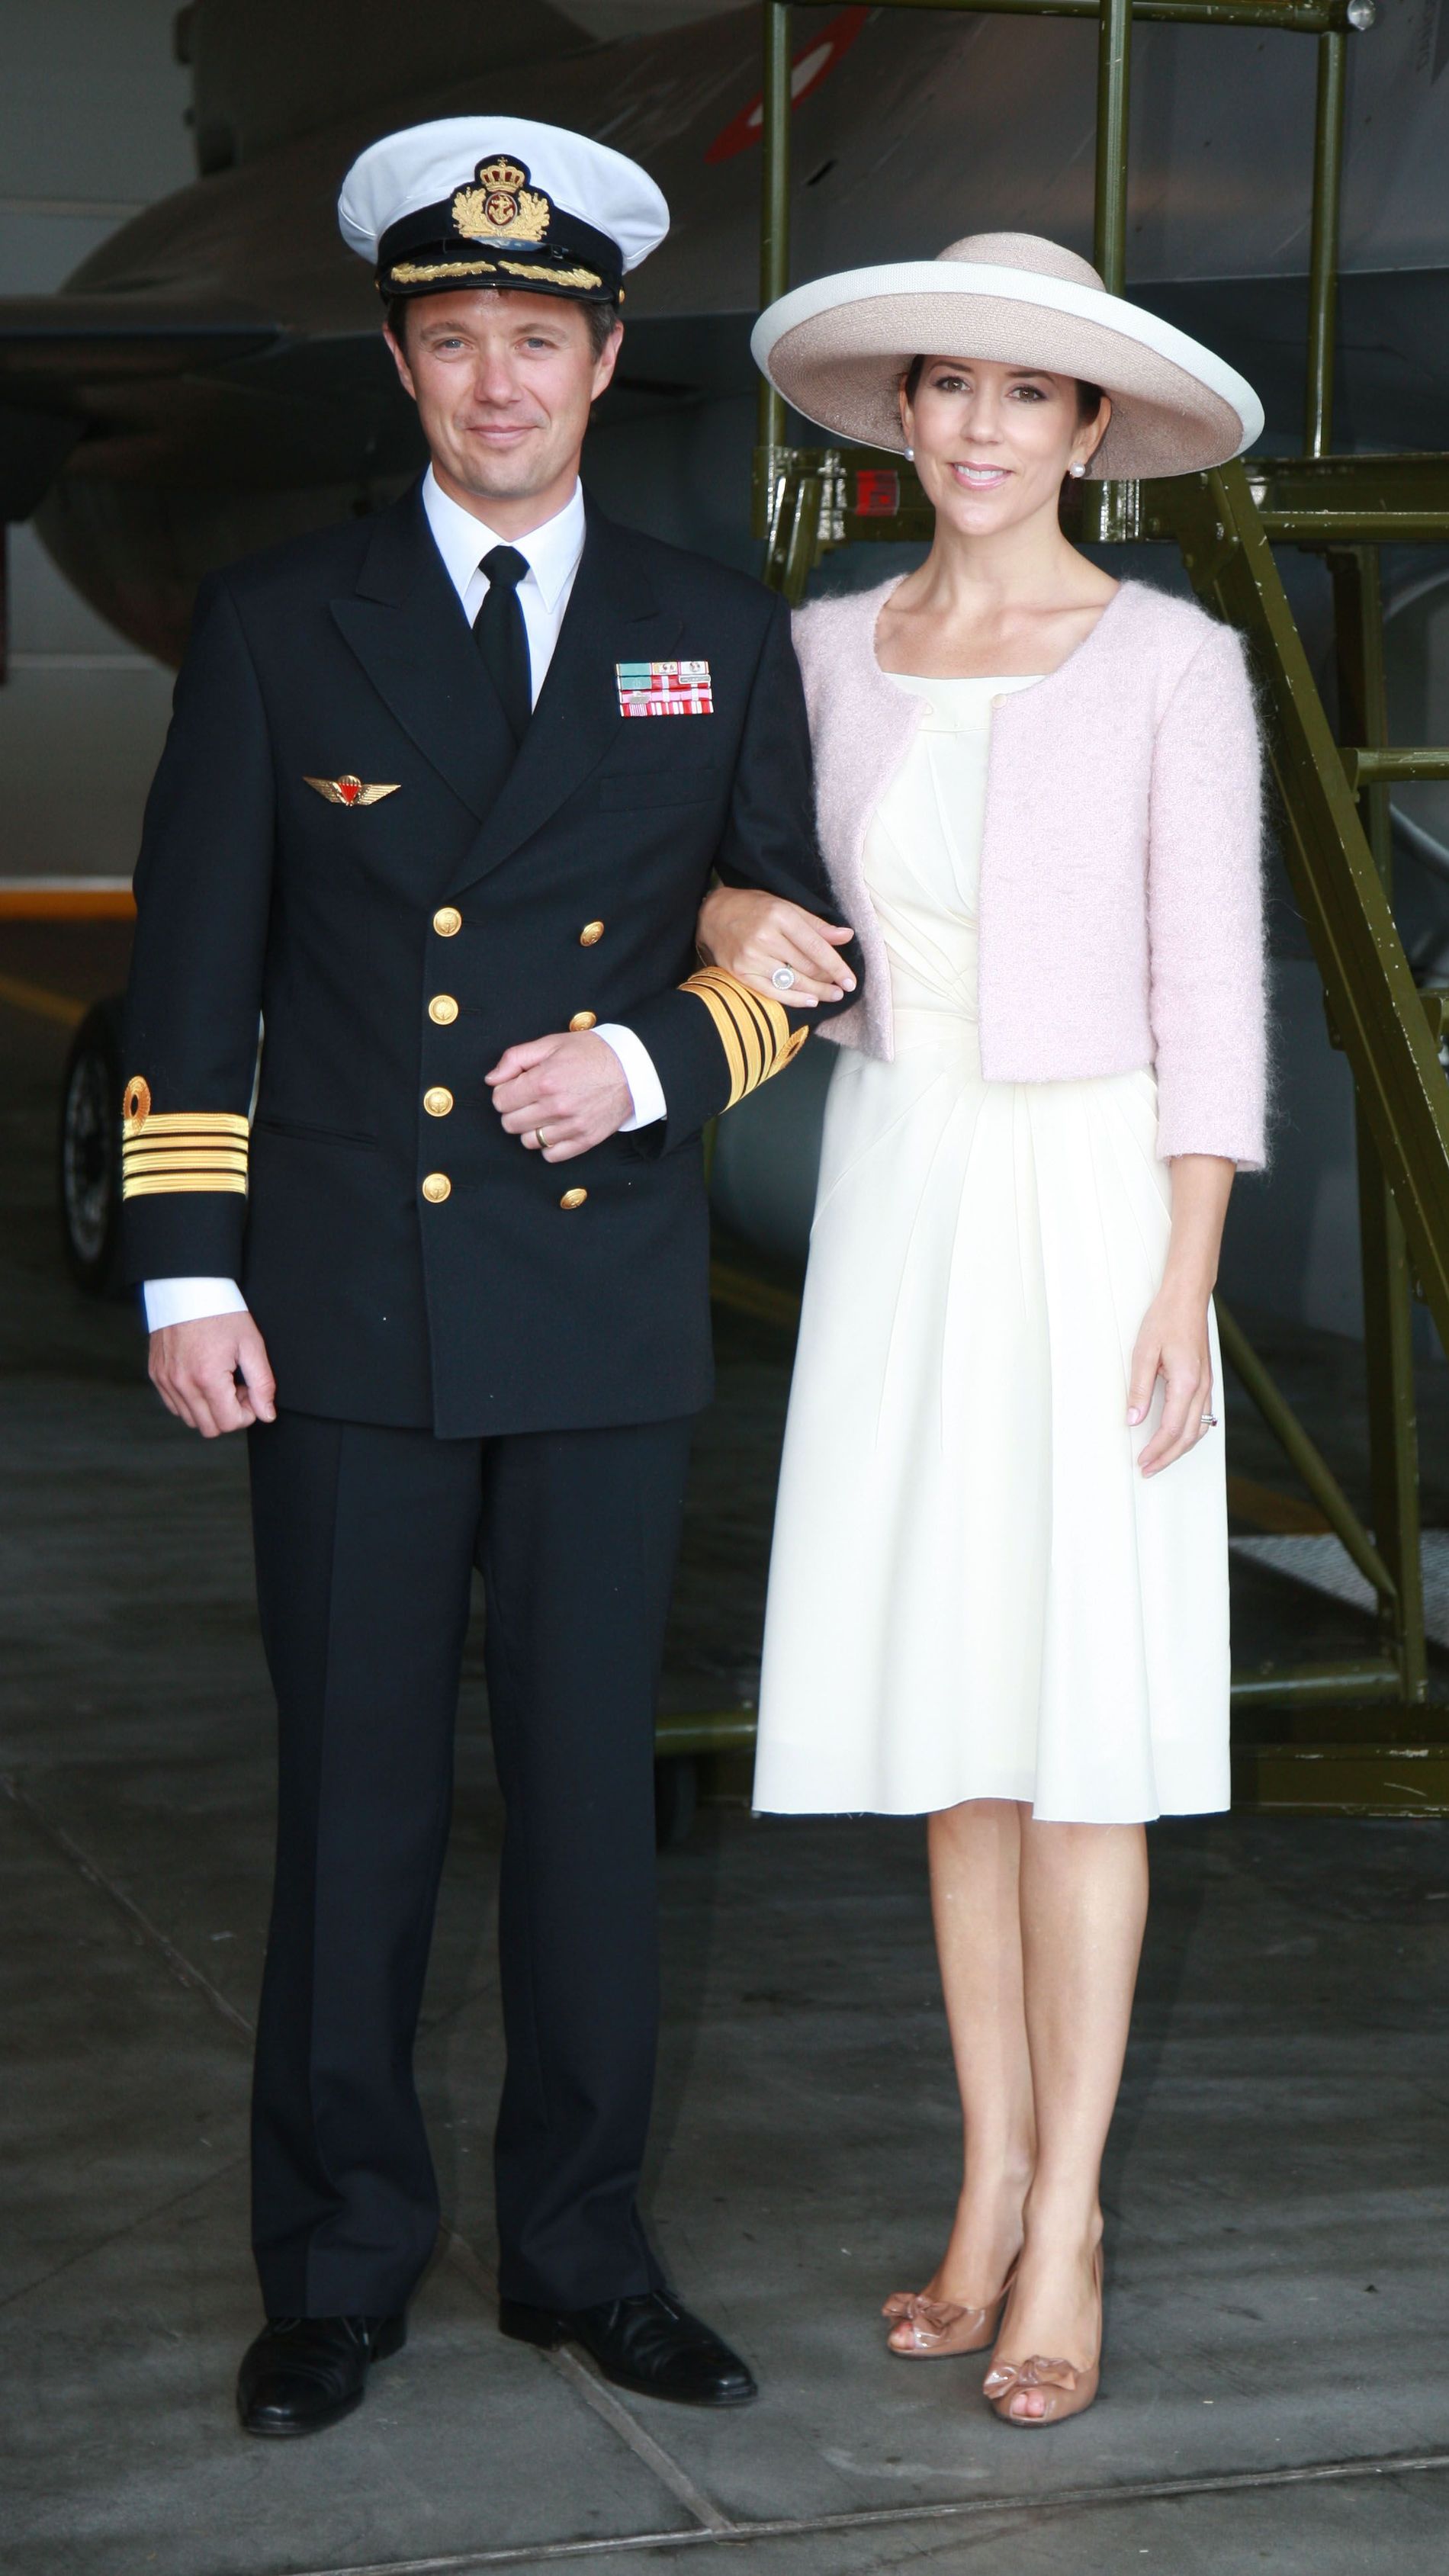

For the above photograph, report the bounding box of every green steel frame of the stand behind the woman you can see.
[727,0,1449,1813]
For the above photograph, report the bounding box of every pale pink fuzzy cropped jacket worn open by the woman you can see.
[794,582,1266,1170]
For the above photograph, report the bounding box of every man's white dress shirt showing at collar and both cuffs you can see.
[144,466,665,1331]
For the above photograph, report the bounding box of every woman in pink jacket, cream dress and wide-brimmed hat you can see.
[702,234,1264,2427]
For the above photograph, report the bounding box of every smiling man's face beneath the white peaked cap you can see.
[387,288,624,499]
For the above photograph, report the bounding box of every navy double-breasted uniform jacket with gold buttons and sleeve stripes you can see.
[124,490,859,1437]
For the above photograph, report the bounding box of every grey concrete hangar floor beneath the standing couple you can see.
[0,961,1449,2576]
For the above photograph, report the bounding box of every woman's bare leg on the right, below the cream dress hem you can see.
[998,1813,1147,2414]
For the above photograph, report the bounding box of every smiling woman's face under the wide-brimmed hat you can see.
[900,358,1111,536]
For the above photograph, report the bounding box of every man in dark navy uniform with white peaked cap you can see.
[124,118,851,2434]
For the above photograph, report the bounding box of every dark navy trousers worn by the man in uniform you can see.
[248,1412,693,2316]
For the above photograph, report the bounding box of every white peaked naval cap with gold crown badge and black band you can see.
[338,116,670,296]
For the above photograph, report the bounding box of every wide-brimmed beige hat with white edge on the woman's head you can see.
[750,232,1264,477]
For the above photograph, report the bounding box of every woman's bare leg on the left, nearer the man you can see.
[902,1798,1034,2308]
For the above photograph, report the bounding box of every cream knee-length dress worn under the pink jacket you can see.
[756,677,1227,1824]
